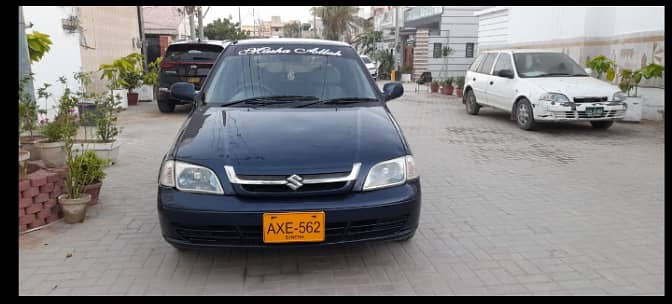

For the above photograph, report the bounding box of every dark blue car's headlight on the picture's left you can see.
[159,160,224,194]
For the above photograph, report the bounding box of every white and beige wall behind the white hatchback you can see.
[475,6,665,119]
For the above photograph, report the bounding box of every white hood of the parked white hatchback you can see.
[526,77,619,100]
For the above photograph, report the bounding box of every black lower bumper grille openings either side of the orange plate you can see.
[173,214,409,246]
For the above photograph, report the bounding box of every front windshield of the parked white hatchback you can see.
[513,53,588,78]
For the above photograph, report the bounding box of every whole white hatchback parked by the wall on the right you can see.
[462,50,627,130]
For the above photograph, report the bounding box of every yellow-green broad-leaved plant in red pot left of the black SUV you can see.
[100,53,144,106]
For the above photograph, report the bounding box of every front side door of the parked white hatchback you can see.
[486,53,517,111]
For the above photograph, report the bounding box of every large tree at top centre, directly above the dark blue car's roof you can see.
[310,6,362,40]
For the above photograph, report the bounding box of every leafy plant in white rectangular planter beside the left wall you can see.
[75,96,121,164]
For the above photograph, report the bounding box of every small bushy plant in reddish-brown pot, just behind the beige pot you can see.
[76,151,109,206]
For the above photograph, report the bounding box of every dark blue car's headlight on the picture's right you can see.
[362,155,418,191]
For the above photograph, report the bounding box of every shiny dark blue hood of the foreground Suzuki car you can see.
[174,106,406,175]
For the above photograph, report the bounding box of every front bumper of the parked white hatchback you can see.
[534,101,627,121]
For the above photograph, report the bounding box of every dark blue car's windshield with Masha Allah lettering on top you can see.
[204,46,377,105]
